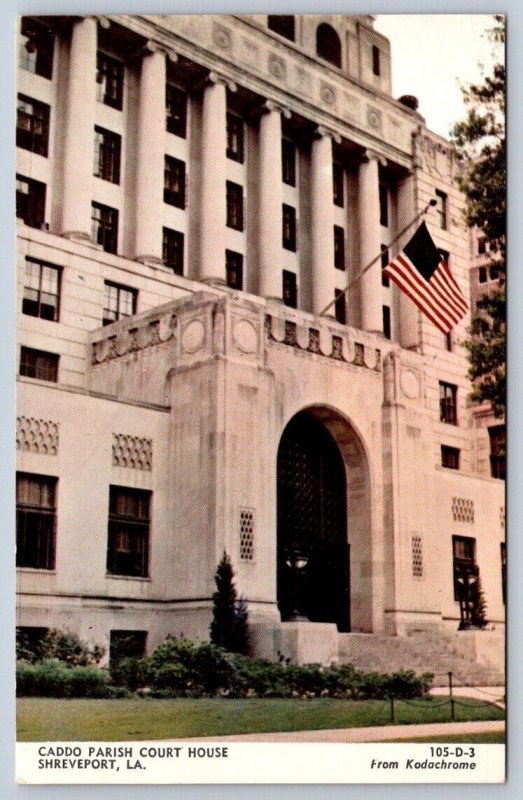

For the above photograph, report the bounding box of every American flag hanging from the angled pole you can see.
[383,222,468,333]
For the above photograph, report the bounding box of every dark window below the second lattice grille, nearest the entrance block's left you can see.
[107,486,151,578]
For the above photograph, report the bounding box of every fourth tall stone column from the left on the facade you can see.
[259,101,290,300]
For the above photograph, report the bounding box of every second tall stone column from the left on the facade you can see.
[134,42,166,264]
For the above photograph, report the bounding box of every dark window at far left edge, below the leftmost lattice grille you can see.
[16,472,57,569]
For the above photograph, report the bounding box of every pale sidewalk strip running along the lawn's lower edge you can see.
[184,720,505,743]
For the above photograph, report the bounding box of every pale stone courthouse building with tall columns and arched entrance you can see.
[16,10,504,678]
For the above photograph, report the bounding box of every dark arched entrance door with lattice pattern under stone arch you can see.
[278,413,350,631]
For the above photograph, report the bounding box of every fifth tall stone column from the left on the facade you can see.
[311,128,335,316]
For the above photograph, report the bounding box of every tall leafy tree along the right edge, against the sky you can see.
[452,15,506,417]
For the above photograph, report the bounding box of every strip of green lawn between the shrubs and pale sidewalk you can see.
[17,697,504,741]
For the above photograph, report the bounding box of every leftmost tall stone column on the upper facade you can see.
[62,17,97,239]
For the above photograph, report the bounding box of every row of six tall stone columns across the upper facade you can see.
[63,17,382,331]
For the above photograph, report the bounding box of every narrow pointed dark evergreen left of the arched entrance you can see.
[211,551,249,655]
